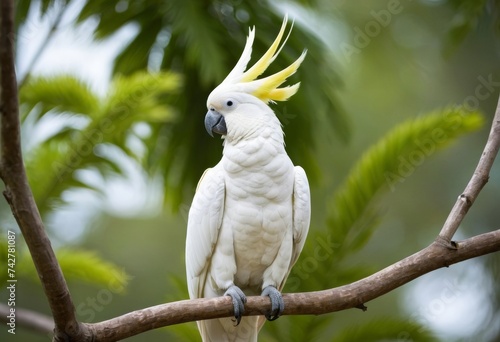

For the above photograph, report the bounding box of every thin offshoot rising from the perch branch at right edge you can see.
[437,98,500,244]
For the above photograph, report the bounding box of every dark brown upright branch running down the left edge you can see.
[0,0,85,340]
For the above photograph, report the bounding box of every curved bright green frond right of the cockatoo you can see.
[327,107,483,260]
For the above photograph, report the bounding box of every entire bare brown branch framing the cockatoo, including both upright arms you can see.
[0,0,500,342]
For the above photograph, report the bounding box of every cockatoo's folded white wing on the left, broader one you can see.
[186,166,225,298]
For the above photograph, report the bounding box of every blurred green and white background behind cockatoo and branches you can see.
[0,0,500,341]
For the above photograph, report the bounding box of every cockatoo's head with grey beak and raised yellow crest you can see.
[205,16,306,136]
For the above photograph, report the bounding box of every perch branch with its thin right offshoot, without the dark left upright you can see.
[76,91,500,342]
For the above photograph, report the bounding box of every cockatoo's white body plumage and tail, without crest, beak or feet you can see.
[186,95,310,341]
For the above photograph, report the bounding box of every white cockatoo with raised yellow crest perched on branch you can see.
[186,16,311,342]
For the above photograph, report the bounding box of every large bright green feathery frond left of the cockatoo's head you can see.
[20,72,181,214]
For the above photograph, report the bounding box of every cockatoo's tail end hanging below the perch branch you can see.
[197,316,259,342]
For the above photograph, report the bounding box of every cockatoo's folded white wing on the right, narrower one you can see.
[288,166,311,272]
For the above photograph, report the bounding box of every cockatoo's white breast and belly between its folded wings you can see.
[222,143,294,289]
